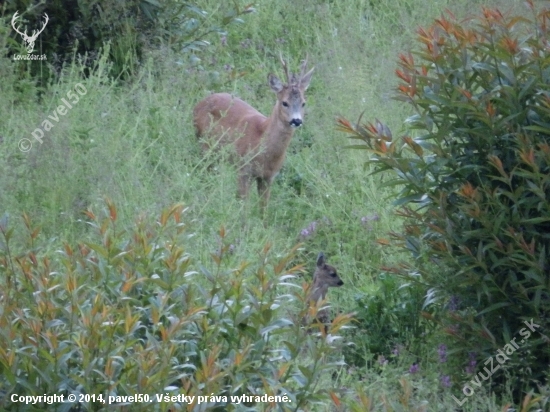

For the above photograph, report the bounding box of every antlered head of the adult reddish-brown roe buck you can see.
[267,55,313,127]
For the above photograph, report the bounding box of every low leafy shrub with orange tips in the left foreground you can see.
[0,202,354,411]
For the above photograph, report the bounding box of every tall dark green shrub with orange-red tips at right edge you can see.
[339,1,550,395]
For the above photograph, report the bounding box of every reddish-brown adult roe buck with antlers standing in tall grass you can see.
[193,56,313,213]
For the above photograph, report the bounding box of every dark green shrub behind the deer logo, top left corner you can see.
[0,0,253,81]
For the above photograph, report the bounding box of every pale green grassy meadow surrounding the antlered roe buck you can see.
[0,0,542,411]
